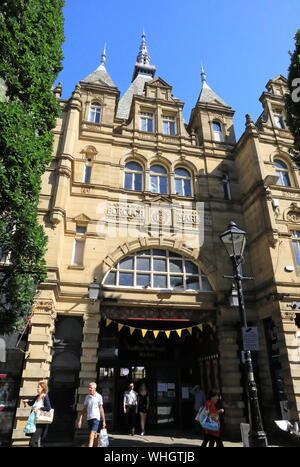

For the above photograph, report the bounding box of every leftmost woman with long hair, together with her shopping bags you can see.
[23,381,53,448]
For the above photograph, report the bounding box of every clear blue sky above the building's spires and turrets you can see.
[56,0,300,138]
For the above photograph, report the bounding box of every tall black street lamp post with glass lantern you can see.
[220,222,268,447]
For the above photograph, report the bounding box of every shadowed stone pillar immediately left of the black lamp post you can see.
[217,308,246,438]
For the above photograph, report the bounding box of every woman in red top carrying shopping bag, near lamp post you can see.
[200,391,224,448]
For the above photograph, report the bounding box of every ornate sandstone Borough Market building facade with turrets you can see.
[12,34,300,446]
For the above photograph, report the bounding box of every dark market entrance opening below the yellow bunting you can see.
[97,320,219,432]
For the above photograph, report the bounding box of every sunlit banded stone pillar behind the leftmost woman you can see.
[12,299,56,446]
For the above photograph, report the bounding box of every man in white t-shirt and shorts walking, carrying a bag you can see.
[78,383,106,448]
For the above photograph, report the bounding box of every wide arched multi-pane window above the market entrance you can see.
[103,249,212,292]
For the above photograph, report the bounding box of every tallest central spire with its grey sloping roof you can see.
[117,31,156,120]
